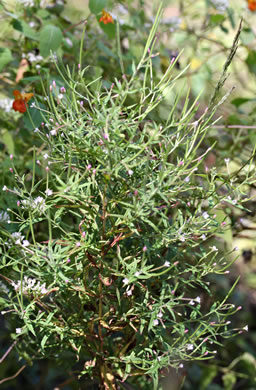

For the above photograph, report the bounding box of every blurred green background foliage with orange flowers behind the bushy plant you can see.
[0,0,256,390]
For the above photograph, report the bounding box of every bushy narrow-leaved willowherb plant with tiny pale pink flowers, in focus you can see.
[1,12,251,389]
